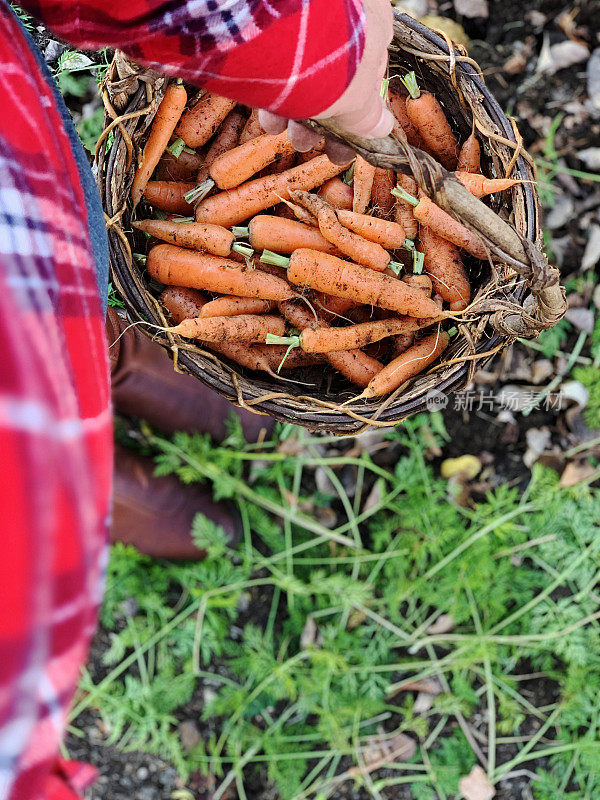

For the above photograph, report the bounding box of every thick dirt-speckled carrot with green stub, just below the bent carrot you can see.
[261,248,439,319]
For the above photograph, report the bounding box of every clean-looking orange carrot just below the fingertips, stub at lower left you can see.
[209,130,294,189]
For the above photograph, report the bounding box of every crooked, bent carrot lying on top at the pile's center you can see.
[292,191,391,272]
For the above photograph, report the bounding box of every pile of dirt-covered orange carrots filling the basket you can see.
[131,73,516,397]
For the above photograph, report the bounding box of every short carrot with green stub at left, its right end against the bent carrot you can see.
[232,214,337,255]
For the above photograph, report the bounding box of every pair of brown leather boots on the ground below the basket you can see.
[106,308,274,559]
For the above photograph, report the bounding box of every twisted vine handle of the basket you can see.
[303,120,567,338]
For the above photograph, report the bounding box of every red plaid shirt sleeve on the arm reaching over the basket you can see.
[21,0,364,119]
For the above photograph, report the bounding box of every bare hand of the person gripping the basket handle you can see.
[259,0,394,164]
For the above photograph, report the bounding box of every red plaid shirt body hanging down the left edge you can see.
[0,0,112,800]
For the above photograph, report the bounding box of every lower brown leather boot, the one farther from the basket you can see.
[110,445,241,560]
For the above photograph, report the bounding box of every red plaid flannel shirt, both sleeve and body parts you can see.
[0,0,364,800]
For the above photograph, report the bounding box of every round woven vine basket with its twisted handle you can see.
[96,14,565,434]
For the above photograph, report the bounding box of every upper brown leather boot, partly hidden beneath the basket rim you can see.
[106,308,274,442]
